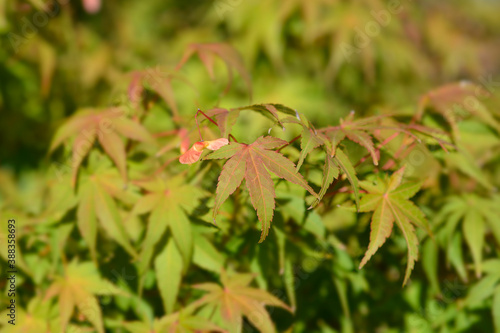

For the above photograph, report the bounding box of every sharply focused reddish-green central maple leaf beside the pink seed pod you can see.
[205,136,318,243]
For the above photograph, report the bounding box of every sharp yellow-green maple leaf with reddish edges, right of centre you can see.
[359,167,431,285]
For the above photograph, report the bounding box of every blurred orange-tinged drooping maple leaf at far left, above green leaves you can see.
[49,108,153,187]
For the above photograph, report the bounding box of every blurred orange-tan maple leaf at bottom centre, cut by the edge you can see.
[189,270,293,332]
